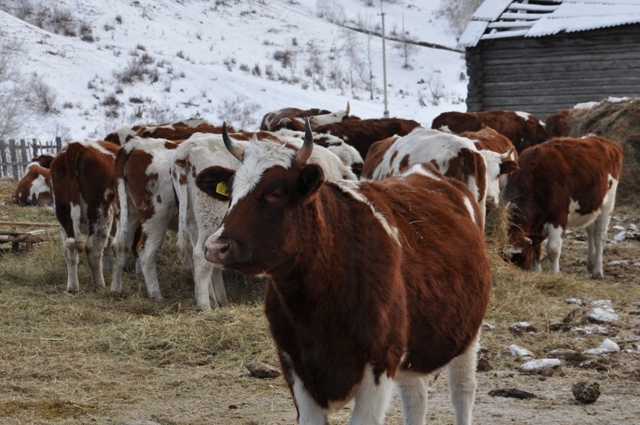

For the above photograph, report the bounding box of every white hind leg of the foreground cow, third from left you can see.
[396,372,429,425]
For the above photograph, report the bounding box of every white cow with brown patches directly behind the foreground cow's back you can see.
[364,127,516,226]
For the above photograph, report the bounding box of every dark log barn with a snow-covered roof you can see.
[458,0,640,119]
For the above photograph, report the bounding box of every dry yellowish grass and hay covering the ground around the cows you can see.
[0,201,640,425]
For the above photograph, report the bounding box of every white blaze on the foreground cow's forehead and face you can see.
[229,140,296,211]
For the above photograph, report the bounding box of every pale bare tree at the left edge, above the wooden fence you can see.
[0,38,33,139]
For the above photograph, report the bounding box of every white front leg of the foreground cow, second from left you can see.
[349,366,394,425]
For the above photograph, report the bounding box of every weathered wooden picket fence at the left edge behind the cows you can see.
[0,137,62,181]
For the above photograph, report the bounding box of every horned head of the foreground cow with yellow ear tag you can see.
[196,121,324,275]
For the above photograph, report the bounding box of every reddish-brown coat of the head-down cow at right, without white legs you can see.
[503,136,622,270]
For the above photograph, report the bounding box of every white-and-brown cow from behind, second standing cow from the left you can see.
[111,137,181,300]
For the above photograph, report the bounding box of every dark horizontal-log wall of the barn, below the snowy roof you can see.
[466,25,640,119]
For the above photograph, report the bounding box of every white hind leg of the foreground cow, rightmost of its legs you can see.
[449,330,480,425]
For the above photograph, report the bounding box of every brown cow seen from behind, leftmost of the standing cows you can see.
[50,141,120,293]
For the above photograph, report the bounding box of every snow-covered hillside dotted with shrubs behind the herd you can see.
[0,0,467,140]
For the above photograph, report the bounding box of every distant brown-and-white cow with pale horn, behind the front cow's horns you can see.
[260,102,351,131]
